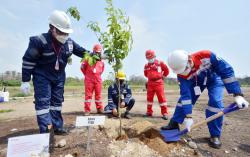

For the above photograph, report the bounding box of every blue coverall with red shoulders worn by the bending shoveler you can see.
[172,50,241,137]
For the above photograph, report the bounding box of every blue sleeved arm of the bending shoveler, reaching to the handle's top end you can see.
[210,53,242,95]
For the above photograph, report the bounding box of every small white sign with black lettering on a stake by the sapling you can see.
[76,116,105,127]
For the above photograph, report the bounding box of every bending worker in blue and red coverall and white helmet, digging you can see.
[161,50,249,149]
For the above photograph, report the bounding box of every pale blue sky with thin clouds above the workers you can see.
[0,0,250,78]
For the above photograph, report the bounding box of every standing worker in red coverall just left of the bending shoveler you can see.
[144,50,169,120]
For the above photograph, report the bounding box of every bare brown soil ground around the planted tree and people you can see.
[0,88,250,157]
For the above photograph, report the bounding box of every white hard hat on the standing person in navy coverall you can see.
[49,10,73,34]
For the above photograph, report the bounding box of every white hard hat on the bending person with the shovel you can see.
[168,50,188,74]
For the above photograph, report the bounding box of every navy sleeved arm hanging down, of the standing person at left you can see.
[22,36,42,82]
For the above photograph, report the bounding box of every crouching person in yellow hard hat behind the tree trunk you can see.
[104,71,135,119]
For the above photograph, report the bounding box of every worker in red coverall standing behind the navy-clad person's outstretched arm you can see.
[81,44,104,115]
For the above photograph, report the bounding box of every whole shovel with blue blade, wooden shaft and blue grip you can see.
[160,103,239,142]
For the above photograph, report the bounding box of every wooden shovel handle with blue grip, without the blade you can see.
[191,103,239,130]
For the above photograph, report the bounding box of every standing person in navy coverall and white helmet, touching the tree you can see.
[21,10,91,135]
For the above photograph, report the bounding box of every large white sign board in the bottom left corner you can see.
[7,133,49,157]
